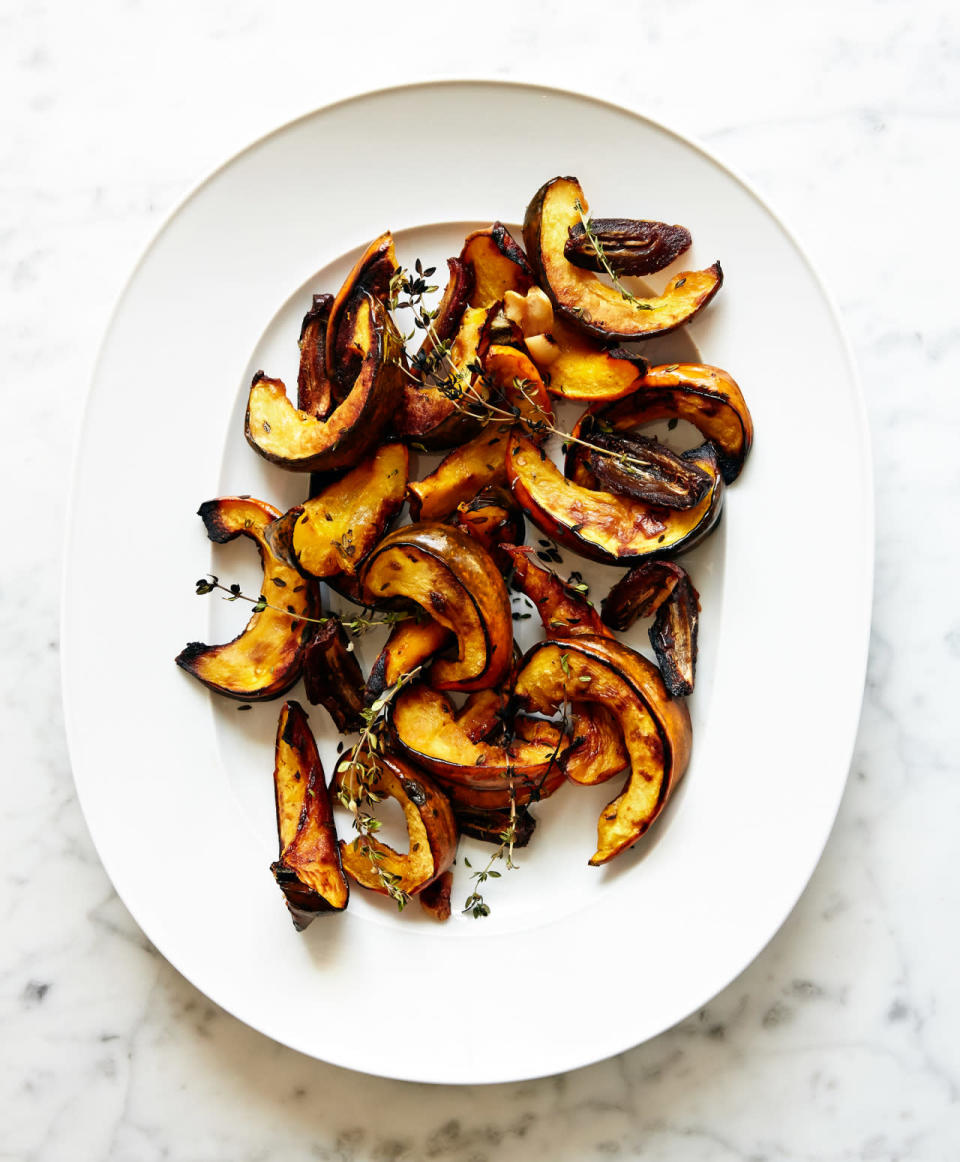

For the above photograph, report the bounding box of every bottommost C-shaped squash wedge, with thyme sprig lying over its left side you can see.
[334,752,457,896]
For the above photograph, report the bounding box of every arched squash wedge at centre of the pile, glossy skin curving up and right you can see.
[360,522,514,690]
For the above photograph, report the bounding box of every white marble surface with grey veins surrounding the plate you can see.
[0,0,960,1162]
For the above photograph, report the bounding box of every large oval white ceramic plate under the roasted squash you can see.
[63,83,872,1082]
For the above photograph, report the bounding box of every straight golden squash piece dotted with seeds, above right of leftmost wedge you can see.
[291,444,410,578]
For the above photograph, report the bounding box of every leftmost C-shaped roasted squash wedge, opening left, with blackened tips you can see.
[177,496,320,702]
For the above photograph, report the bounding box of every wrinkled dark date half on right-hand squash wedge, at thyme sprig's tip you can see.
[586,432,712,510]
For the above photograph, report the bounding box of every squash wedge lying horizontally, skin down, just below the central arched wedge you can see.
[388,684,569,810]
